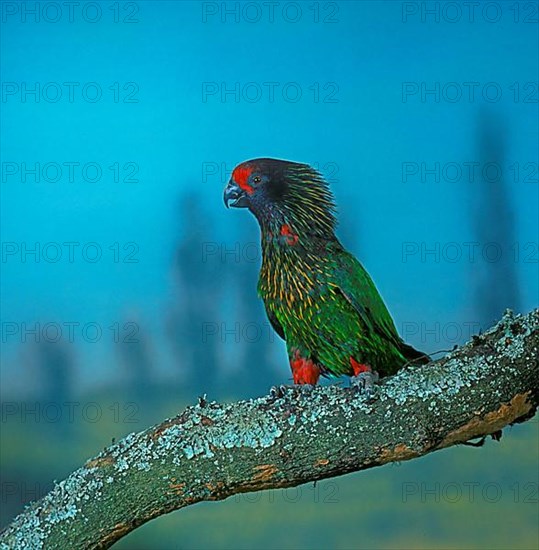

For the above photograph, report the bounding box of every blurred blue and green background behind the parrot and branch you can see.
[1,1,539,548]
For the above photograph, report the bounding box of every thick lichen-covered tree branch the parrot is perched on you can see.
[0,310,539,549]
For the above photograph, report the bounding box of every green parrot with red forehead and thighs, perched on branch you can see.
[223,158,430,386]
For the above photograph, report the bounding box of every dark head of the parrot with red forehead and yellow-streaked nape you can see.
[224,158,336,236]
